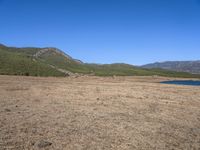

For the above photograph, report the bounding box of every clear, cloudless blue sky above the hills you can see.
[0,0,200,65]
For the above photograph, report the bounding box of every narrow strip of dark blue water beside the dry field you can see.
[160,80,200,86]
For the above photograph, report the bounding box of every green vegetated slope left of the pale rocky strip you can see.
[0,46,64,76]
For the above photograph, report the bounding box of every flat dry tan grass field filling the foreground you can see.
[0,76,200,150]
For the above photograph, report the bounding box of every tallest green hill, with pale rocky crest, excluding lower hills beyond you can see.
[0,44,86,76]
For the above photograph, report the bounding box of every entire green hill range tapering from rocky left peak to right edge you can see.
[0,44,200,78]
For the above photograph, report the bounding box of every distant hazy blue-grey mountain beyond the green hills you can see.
[142,61,200,74]
